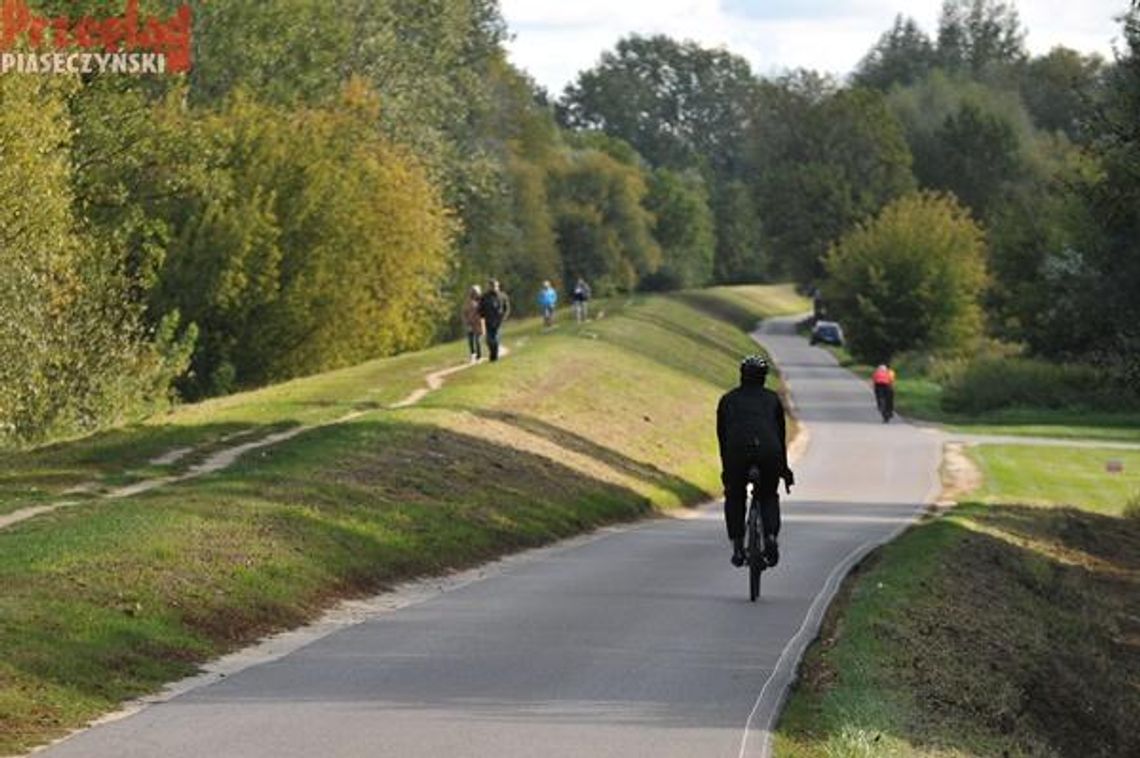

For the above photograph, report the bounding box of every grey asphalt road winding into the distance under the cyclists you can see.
[42,320,942,758]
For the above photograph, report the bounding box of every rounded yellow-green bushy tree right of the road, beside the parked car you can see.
[824,193,986,362]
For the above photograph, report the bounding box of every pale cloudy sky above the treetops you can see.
[502,0,1129,95]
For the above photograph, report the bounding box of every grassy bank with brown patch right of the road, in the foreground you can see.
[776,446,1140,758]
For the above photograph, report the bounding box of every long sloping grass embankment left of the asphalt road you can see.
[0,282,800,755]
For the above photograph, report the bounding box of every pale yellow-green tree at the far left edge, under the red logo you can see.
[0,76,194,442]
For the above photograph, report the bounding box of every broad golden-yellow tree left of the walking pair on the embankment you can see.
[154,81,453,396]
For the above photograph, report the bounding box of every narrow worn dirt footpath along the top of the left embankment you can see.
[0,345,510,529]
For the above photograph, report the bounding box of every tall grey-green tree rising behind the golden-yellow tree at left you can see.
[190,0,508,321]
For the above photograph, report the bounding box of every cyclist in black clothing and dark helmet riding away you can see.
[716,356,796,567]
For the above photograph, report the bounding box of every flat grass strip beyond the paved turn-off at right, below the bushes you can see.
[829,347,1140,442]
